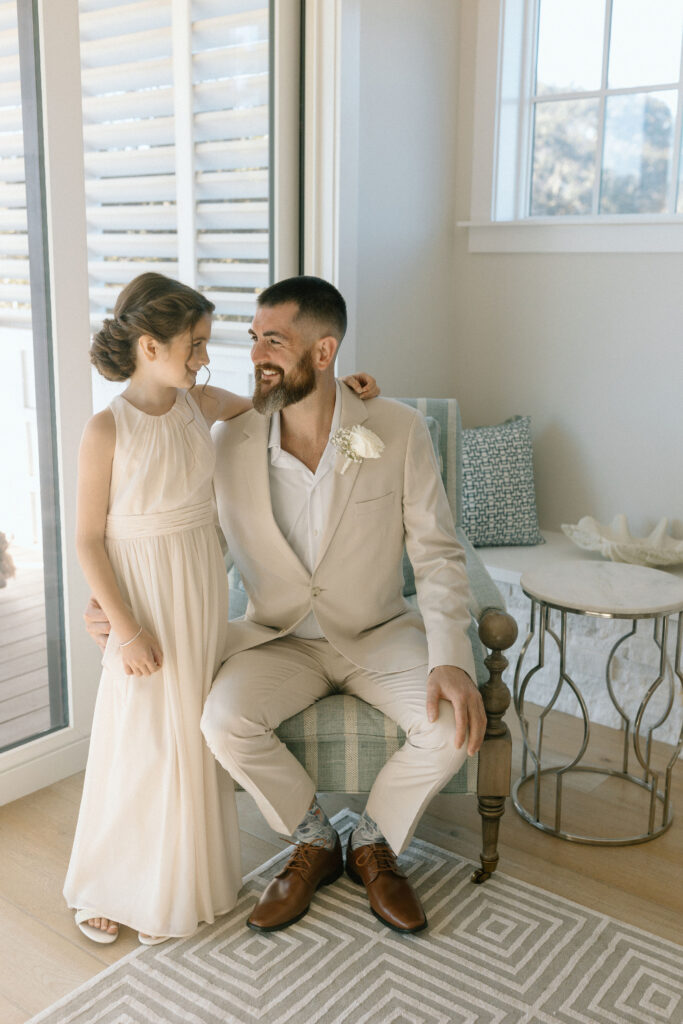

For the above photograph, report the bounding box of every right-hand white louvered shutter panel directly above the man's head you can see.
[191,0,270,344]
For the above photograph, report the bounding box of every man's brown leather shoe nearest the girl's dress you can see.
[247,836,344,932]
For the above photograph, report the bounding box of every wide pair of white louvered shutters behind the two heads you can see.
[80,0,269,345]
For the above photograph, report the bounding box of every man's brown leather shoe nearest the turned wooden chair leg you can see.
[346,836,427,932]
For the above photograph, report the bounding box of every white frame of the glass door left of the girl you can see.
[0,0,100,803]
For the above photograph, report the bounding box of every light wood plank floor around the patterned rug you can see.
[0,716,683,1024]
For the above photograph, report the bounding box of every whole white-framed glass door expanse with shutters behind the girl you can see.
[0,0,300,786]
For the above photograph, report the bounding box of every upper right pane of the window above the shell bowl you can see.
[608,0,683,89]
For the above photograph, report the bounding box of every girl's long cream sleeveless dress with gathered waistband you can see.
[63,391,241,936]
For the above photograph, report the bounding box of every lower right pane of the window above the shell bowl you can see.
[600,91,677,213]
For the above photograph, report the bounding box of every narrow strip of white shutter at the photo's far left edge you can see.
[0,0,31,328]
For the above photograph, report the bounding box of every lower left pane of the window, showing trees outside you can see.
[530,99,598,217]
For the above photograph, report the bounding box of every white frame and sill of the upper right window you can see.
[458,0,683,253]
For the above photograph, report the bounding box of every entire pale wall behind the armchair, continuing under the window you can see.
[348,0,683,537]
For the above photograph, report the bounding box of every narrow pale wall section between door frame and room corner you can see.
[340,0,459,396]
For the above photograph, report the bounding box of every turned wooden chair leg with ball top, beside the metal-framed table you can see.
[472,609,517,885]
